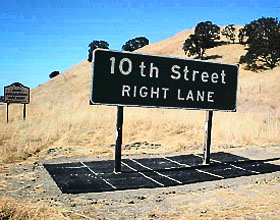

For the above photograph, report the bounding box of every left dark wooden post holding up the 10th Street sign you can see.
[115,106,123,172]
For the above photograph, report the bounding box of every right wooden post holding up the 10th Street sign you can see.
[203,111,213,164]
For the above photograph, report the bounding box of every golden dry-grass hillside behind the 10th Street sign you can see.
[0,27,280,162]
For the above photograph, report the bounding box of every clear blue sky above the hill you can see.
[0,0,280,95]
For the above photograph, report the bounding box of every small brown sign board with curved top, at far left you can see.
[4,82,30,104]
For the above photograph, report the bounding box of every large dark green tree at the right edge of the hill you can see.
[240,17,280,69]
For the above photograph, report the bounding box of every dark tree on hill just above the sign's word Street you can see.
[182,21,220,59]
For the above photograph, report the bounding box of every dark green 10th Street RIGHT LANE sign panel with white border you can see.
[91,49,238,111]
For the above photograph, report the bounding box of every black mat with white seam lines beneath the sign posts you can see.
[44,153,280,193]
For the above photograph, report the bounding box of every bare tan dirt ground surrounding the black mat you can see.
[0,146,280,219]
